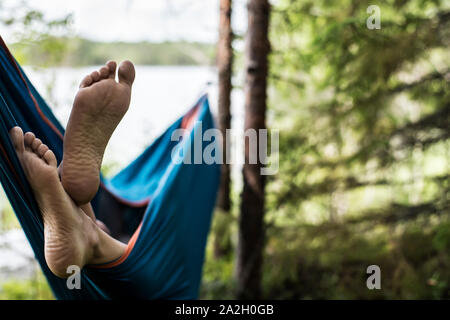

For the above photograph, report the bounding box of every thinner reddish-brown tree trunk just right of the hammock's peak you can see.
[214,0,233,258]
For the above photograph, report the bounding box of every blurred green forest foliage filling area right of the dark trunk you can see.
[264,0,450,299]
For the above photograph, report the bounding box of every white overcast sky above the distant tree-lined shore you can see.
[0,0,246,42]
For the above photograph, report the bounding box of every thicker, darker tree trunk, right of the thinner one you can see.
[236,0,270,299]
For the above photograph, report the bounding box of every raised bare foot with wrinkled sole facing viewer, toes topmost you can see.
[60,61,135,205]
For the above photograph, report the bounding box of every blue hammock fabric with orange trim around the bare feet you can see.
[0,37,220,299]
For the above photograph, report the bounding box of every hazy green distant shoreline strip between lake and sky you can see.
[10,36,215,67]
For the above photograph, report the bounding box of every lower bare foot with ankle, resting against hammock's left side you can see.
[10,127,125,278]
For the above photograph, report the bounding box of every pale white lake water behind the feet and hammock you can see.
[0,66,244,280]
